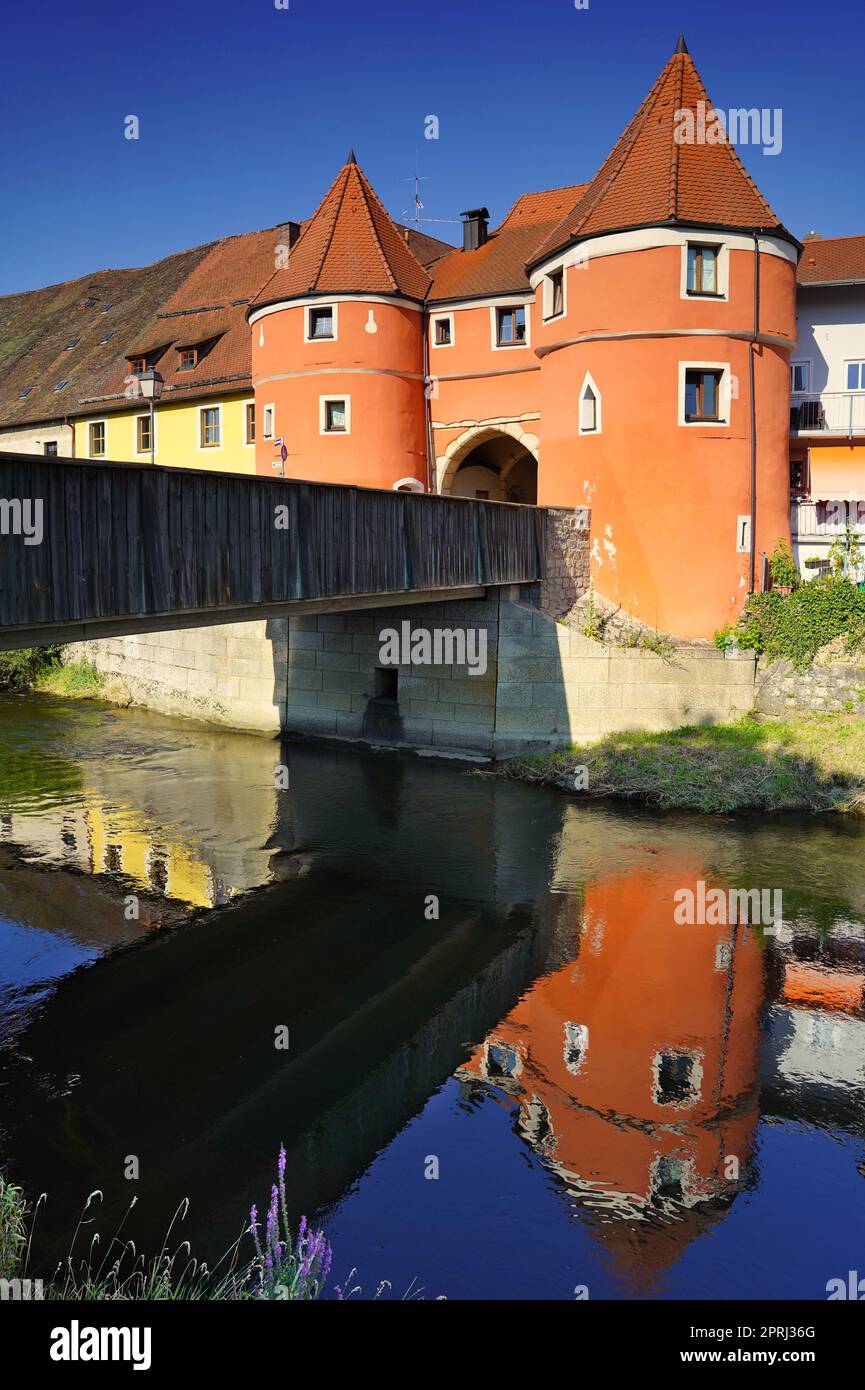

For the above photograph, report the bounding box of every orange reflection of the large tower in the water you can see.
[462,862,762,1272]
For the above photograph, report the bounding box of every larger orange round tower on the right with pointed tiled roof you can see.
[530,40,801,637]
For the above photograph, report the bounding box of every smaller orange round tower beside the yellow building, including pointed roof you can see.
[249,152,430,489]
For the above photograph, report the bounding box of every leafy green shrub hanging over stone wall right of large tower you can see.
[736,574,865,670]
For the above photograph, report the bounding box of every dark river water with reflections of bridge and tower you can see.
[0,695,865,1298]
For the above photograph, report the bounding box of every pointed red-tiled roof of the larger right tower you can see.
[533,35,798,265]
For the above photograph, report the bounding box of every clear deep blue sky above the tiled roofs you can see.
[0,0,865,293]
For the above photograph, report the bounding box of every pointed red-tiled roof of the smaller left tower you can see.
[254,150,430,304]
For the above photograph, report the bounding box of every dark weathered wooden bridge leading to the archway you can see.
[0,453,544,648]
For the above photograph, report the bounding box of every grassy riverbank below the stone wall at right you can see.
[499,714,865,815]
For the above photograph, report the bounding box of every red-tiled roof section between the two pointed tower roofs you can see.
[430,183,588,303]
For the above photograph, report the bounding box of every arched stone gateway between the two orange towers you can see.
[437,424,538,505]
